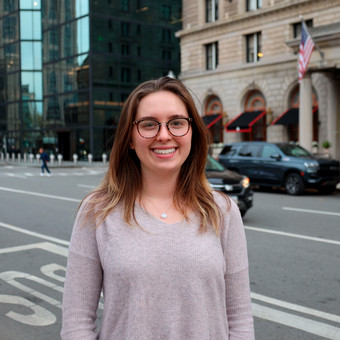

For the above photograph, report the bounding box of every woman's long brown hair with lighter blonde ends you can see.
[81,77,228,234]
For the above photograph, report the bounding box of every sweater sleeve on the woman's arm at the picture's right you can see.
[221,195,255,340]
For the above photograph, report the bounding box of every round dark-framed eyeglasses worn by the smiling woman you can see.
[133,118,192,138]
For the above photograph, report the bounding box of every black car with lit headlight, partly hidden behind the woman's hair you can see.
[205,155,253,216]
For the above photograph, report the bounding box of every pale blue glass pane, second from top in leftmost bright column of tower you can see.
[20,11,41,40]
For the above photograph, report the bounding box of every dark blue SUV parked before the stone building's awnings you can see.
[219,142,340,195]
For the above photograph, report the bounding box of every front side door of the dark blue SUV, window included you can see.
[258,144,285,185]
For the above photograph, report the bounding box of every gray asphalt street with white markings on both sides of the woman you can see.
[0,164,340,340]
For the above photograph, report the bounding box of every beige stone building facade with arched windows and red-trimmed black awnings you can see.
[177,0,340,159]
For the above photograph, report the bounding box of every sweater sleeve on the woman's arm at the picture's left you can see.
[61,203,103,340]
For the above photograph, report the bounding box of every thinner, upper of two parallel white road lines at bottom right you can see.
[250,293,340,323]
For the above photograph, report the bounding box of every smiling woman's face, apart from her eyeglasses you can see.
[130,91,192,176]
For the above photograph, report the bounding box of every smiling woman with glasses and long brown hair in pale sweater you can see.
[61,77,254,340]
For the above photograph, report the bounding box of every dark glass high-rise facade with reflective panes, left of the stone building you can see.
[0,0,182,160]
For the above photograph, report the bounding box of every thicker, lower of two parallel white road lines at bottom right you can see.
[252,303,340,340]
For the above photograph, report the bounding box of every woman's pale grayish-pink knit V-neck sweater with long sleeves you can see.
[61,193,254,340]
